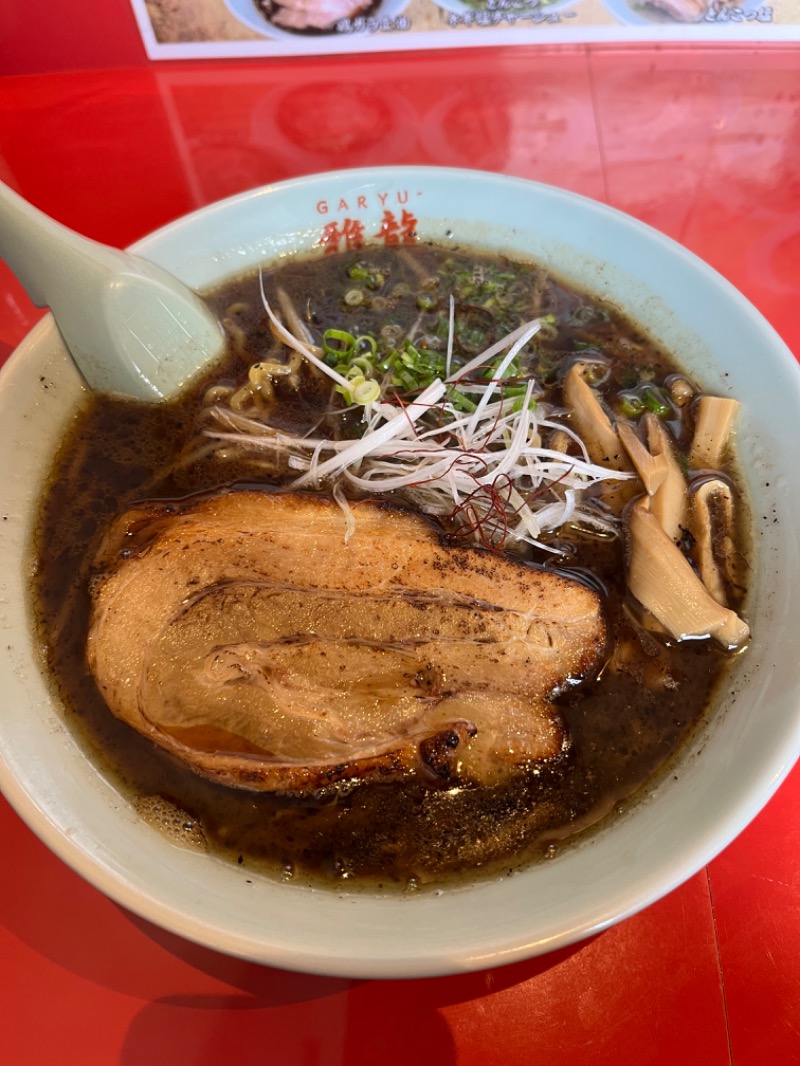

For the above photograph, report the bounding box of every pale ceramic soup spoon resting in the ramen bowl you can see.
[0,182,223,400]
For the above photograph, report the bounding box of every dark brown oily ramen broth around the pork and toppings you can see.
[34,246,746,888]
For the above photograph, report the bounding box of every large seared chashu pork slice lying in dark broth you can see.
[87,490,606,792]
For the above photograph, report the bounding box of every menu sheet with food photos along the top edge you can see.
[131,0,800,60]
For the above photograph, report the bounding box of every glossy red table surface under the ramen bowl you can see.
[0,46,800,1066]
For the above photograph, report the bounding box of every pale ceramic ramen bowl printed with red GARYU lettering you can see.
[0,167,800,976]
